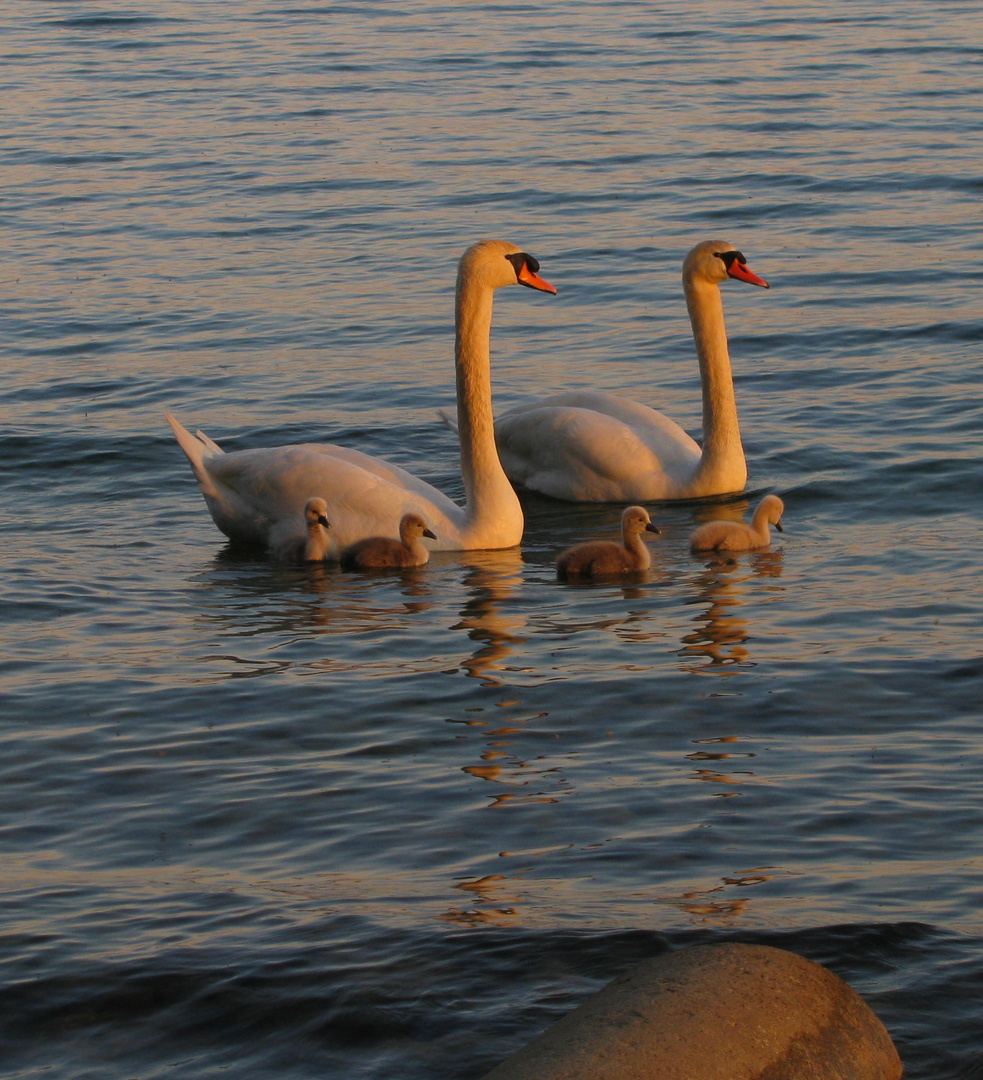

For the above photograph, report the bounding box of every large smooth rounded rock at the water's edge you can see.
[484,944,901,1080]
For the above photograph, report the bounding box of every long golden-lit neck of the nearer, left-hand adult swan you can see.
[454,266,522,548]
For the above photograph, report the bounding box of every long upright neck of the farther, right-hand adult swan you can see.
[684,280,748,491]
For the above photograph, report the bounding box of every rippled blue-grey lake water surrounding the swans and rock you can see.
[0,0,983,1080]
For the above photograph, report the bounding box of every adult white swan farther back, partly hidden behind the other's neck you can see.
[490,240,768,502]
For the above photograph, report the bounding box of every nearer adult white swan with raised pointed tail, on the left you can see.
[165,240,556,555]
